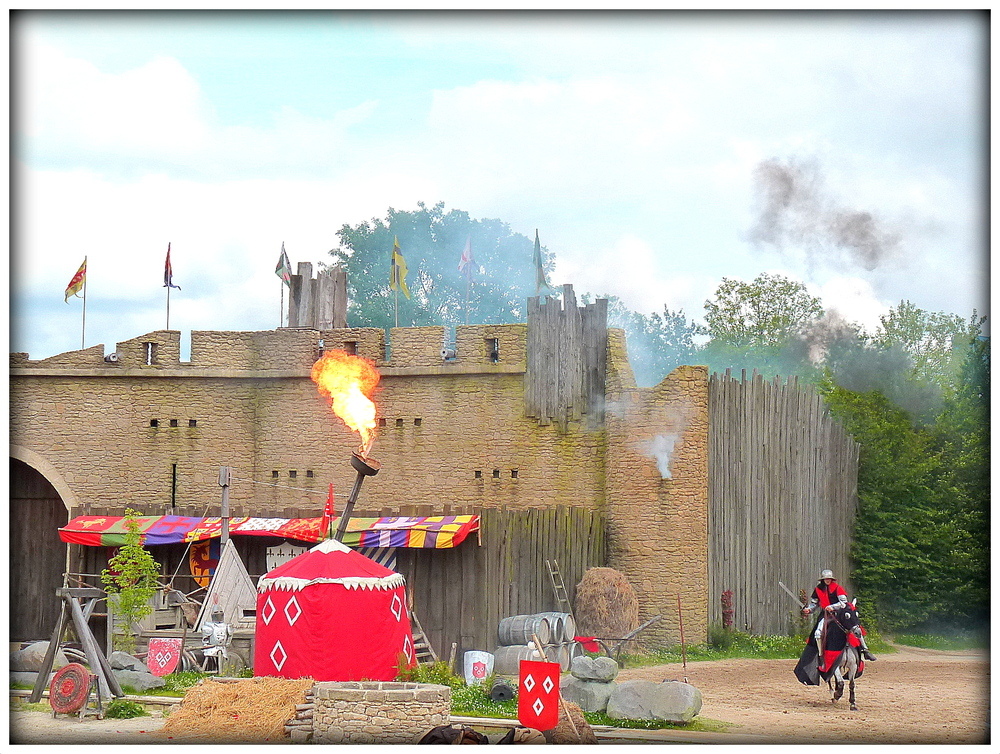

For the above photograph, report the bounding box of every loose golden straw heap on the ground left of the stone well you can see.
[158,676,313,743]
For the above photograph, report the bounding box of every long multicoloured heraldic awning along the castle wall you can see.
[59,515,479,549]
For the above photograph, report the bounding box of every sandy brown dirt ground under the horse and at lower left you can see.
[9,648,990,744]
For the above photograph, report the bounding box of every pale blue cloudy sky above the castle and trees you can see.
[10,11,989,358]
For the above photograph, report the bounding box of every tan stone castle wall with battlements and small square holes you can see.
[10,324,708,642]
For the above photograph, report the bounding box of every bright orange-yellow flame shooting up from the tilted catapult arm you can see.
[310,351,382,457]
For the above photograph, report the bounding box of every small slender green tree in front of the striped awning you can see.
[101,508,160,653]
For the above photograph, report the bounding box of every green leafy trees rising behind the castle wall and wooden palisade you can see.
[331,203,990,631]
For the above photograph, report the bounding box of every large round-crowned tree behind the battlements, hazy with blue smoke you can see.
[330,202,553,328]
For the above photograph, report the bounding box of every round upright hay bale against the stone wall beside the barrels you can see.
[573,568,639,639]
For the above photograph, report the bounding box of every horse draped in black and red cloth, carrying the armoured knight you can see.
[794,602,864,712]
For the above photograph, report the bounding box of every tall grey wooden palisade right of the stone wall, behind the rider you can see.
[708,370,859,634]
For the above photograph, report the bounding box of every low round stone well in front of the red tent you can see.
[311,681,451,744]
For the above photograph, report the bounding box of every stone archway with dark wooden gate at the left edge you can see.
[8,447,70,642]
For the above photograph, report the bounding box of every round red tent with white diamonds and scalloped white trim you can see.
[254,539,416,681]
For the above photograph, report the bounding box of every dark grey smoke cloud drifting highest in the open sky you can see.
[748,158,902,271]
